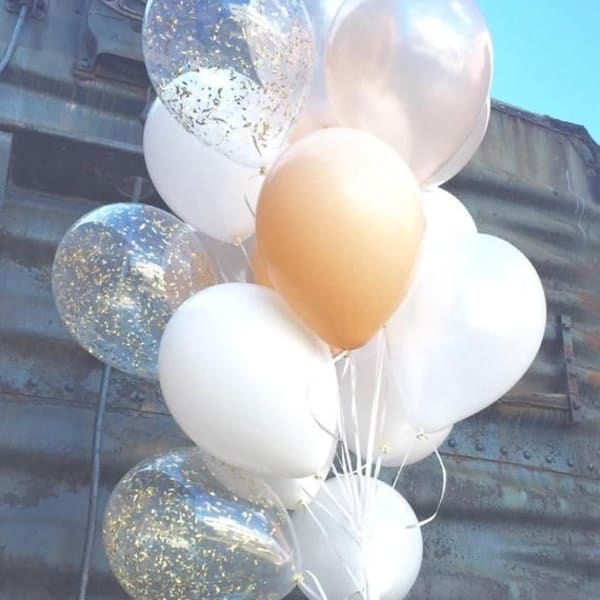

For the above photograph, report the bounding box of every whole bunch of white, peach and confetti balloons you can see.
[53,0,546,600]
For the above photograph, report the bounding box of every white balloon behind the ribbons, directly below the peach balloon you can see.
[340,334,452,467]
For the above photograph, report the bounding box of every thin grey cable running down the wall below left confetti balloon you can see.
[77,365,112,600]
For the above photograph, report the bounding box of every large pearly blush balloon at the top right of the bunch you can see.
[325,0,492,182]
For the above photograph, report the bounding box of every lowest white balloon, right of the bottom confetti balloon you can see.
[292,475,423,600]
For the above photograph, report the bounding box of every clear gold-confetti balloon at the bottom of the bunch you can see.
[104,448,300,600]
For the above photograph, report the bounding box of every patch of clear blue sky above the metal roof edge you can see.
[478,0,600,143]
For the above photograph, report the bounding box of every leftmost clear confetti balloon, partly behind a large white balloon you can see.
[52,203,215,378]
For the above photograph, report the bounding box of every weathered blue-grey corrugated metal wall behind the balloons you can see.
[0,0,600,600]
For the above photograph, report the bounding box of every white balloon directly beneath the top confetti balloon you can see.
[144,99,264,243]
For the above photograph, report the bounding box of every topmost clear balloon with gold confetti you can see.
[142,0,313,166]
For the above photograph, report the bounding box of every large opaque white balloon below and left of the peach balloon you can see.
[159,283,339,478]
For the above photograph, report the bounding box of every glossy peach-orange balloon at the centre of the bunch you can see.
[256,127,424,349]
